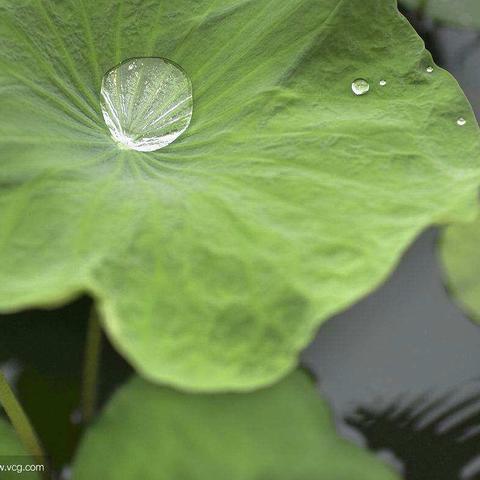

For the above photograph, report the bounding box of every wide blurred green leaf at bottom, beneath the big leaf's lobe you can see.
[73,372,397,480]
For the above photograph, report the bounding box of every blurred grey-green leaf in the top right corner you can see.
[400,0,480,29]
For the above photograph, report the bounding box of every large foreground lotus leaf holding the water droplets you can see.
[0,0,480,390]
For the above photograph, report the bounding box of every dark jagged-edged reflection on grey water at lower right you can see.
[345,389,480,480]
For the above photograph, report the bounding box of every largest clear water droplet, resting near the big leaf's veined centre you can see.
[101,57,193,152]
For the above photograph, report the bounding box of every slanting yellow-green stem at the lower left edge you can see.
[0,371,46,464]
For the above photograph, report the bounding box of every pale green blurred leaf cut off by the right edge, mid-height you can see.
[440,217,480,323]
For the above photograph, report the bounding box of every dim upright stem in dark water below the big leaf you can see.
[82,306,102,423]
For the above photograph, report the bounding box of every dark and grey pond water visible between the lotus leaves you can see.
[0,0,480,480]
